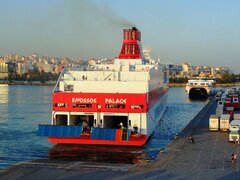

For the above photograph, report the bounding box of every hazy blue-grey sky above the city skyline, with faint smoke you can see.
[0,0,240,73]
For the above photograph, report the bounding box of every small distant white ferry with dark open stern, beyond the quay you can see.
[185,78,217,98]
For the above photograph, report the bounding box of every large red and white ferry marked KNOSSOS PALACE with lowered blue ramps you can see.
[37,27,169,146]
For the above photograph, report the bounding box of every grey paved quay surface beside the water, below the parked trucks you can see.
[0,100,240,180]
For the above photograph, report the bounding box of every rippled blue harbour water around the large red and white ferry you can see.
[0,85,208,169]
